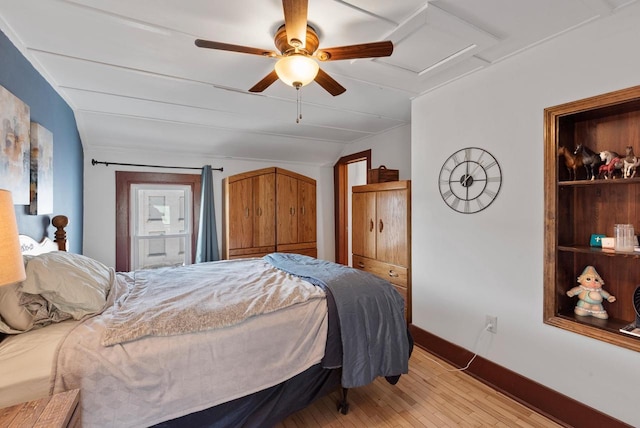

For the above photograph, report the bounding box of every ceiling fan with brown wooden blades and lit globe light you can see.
[195,0,393,96]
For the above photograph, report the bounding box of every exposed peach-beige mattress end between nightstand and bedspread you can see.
[0,320,78,407]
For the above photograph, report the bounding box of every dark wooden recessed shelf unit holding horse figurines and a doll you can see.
[544,86,640,352]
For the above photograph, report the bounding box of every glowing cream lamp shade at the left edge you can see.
[0,189,26,285]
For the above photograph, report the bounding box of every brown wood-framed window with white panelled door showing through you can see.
[116,171,200,272]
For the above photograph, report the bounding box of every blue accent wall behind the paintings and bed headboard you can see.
[0,32,84,253]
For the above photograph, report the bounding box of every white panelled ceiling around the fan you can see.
[0,0,635,165]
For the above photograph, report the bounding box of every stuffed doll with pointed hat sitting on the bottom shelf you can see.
[567,266,616,320]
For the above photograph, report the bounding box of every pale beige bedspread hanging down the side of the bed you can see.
[52,259,327,427]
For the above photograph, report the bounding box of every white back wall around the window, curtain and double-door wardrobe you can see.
[83,148,335,266]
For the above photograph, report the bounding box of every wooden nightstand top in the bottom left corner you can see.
[0,389,80,428]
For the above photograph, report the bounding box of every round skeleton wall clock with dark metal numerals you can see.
[438,147,502,214]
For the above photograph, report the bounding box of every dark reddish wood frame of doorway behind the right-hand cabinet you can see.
[333,149,371,265]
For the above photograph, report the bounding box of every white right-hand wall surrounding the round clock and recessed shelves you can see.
[411,4,640,426]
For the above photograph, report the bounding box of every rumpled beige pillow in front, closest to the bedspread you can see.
[20,251,114,319]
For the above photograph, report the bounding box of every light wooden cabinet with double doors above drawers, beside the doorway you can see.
[351,180,411,323]
